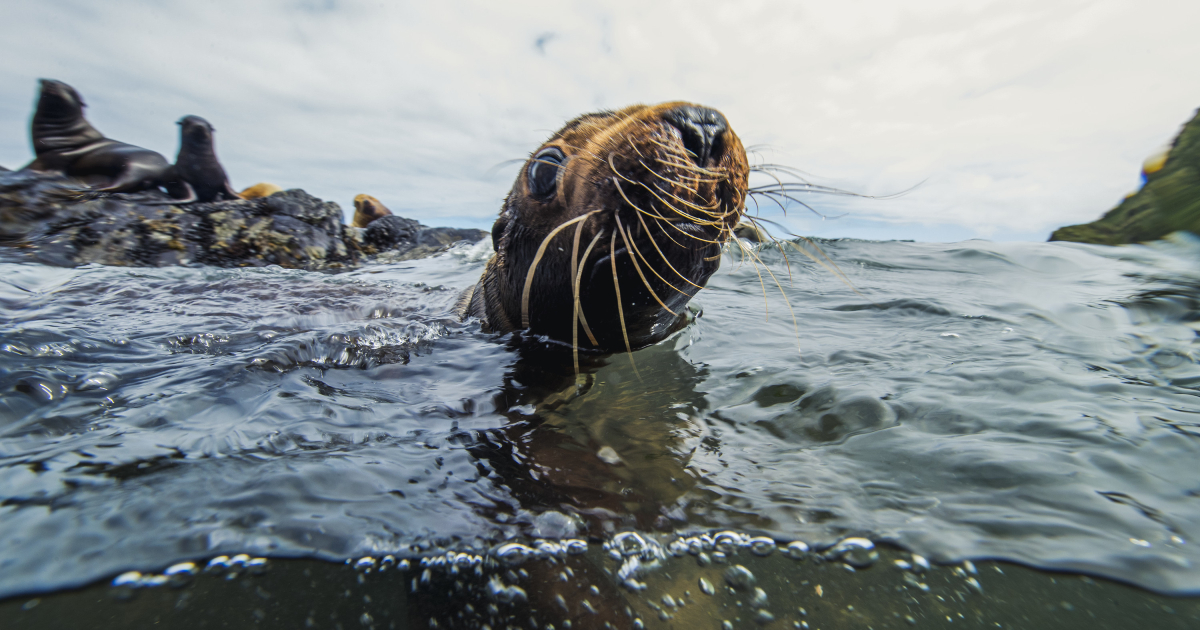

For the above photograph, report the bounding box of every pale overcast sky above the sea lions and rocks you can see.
[0,0,1200,240]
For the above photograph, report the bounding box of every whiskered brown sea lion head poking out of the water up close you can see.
[467,102,749,352]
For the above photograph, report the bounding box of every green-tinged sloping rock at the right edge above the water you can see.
[1050,110,1200,245]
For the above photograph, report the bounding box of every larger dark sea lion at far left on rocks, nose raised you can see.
[24,79,172,192]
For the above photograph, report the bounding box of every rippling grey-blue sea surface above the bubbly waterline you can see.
[0,231,1200,598]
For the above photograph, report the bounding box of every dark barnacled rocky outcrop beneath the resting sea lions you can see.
[0,172,487,269]
